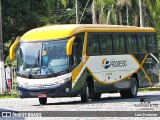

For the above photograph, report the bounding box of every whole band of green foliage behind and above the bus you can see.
[2,0,160,64]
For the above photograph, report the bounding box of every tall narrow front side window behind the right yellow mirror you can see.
[71,34,84,70]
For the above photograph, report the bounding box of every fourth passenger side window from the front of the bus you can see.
[125,34,138,53]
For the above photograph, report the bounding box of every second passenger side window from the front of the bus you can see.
[99,34,113,55]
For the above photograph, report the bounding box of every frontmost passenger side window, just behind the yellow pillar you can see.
[87,34,100,56]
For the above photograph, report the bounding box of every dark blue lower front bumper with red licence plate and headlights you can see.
[18,81,72,98]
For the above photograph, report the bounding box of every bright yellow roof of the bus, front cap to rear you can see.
[21,24,155,41]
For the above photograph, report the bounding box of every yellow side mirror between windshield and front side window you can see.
[66,36,76,55]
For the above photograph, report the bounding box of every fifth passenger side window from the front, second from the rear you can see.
[138,34,147,53]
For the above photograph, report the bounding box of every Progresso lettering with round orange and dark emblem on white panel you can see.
[102,58,127,69]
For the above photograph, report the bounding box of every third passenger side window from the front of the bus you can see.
[113,34,126,54]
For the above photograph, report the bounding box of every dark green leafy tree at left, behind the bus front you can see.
[2,0,53,60]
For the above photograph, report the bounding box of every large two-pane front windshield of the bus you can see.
[17,40,68,75]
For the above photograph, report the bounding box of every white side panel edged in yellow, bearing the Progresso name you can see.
[86,55,139,83]
